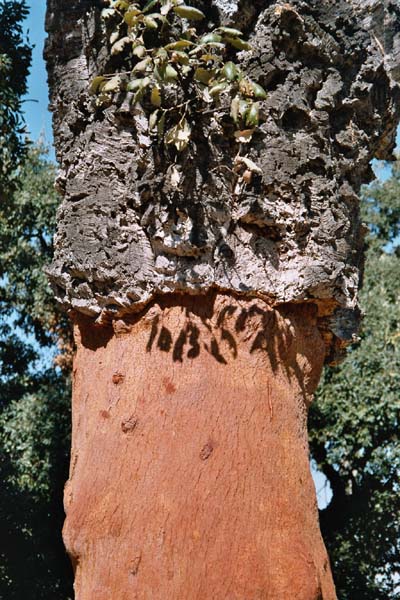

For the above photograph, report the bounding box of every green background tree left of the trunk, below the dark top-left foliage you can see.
[0,147,72,600]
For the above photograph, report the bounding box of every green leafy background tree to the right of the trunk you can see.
[310,164,400,600]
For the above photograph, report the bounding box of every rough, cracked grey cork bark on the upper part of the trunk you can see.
[46,0,400,359]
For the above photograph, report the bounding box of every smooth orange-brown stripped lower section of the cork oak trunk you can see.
[64,295,336,600]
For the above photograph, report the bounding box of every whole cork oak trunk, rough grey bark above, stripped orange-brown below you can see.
[46,0,399,600]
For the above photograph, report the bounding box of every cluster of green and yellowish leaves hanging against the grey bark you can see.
[90,0,266,152]
